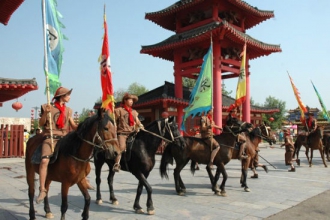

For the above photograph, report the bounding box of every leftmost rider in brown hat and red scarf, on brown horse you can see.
[36,87,93,204]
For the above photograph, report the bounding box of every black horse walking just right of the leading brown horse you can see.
[94,117,185,215]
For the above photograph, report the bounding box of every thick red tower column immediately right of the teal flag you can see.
[213,39,222,132]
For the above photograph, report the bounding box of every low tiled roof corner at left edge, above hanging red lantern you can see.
[0,78,38,103]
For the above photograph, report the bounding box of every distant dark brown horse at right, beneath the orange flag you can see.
[293,126,328,167]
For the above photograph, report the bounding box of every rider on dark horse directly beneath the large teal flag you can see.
[200,109,222,169]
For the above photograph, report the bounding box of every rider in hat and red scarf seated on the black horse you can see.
[112,93,143,172]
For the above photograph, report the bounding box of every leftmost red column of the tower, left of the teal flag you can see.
[174,52,183,128]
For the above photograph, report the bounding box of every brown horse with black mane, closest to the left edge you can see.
[25,109,120,220]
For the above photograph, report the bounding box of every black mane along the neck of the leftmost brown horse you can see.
[57,114,114,156]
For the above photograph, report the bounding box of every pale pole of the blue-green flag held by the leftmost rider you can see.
[41,0,54,153]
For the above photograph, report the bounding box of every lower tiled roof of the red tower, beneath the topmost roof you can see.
[140,21,282,61]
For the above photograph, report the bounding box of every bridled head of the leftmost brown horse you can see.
[93,108,120,159]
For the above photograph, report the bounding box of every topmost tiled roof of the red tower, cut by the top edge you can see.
[145,0,274,31]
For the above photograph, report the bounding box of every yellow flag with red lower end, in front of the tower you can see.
[227,42,246,112]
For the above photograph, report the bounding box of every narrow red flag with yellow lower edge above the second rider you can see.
[99,9,115,115]
